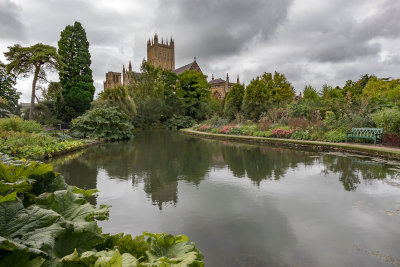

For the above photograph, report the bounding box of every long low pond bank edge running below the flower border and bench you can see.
[180,129,400,160]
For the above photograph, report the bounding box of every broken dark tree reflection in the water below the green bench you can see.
[322,154,397,191]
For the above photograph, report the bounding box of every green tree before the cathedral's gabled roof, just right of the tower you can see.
[177,70,211,120]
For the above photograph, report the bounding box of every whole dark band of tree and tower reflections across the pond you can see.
[55,131,398,209]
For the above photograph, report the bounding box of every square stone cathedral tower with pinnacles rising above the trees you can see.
[147,34,175,71]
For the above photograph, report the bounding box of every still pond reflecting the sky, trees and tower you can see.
[53,131,400,266]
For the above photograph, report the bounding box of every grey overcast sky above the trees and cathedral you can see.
[0,0,400,102]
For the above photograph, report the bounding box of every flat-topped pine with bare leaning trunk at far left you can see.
[4,44,62,120]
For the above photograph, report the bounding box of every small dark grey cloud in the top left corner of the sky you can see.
[0,0,25,40]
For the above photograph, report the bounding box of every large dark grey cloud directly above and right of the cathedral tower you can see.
[156,0,292,60]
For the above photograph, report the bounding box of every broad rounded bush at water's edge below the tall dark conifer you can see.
[71,107,134,141]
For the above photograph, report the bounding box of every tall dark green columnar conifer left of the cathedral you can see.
[56,21,95,121]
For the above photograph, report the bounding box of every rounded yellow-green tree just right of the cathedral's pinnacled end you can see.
[242,71,295,120]
